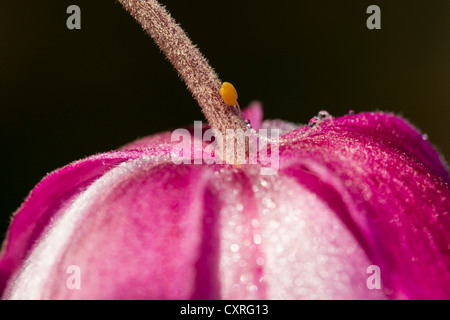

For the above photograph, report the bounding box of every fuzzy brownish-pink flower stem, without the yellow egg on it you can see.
[119,0,247,134]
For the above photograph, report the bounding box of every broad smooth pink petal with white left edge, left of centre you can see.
[3,157,223,299]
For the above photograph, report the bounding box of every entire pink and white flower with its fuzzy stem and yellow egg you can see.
[0,0,450,299]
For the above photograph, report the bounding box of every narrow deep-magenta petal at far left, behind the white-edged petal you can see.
[0,152,139,294]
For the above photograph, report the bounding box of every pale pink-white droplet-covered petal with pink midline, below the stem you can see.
[212,166,385,299]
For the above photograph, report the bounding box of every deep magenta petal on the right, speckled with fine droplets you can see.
[280,113,450,299]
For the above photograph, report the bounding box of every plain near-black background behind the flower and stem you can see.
[0,0,450,239]
